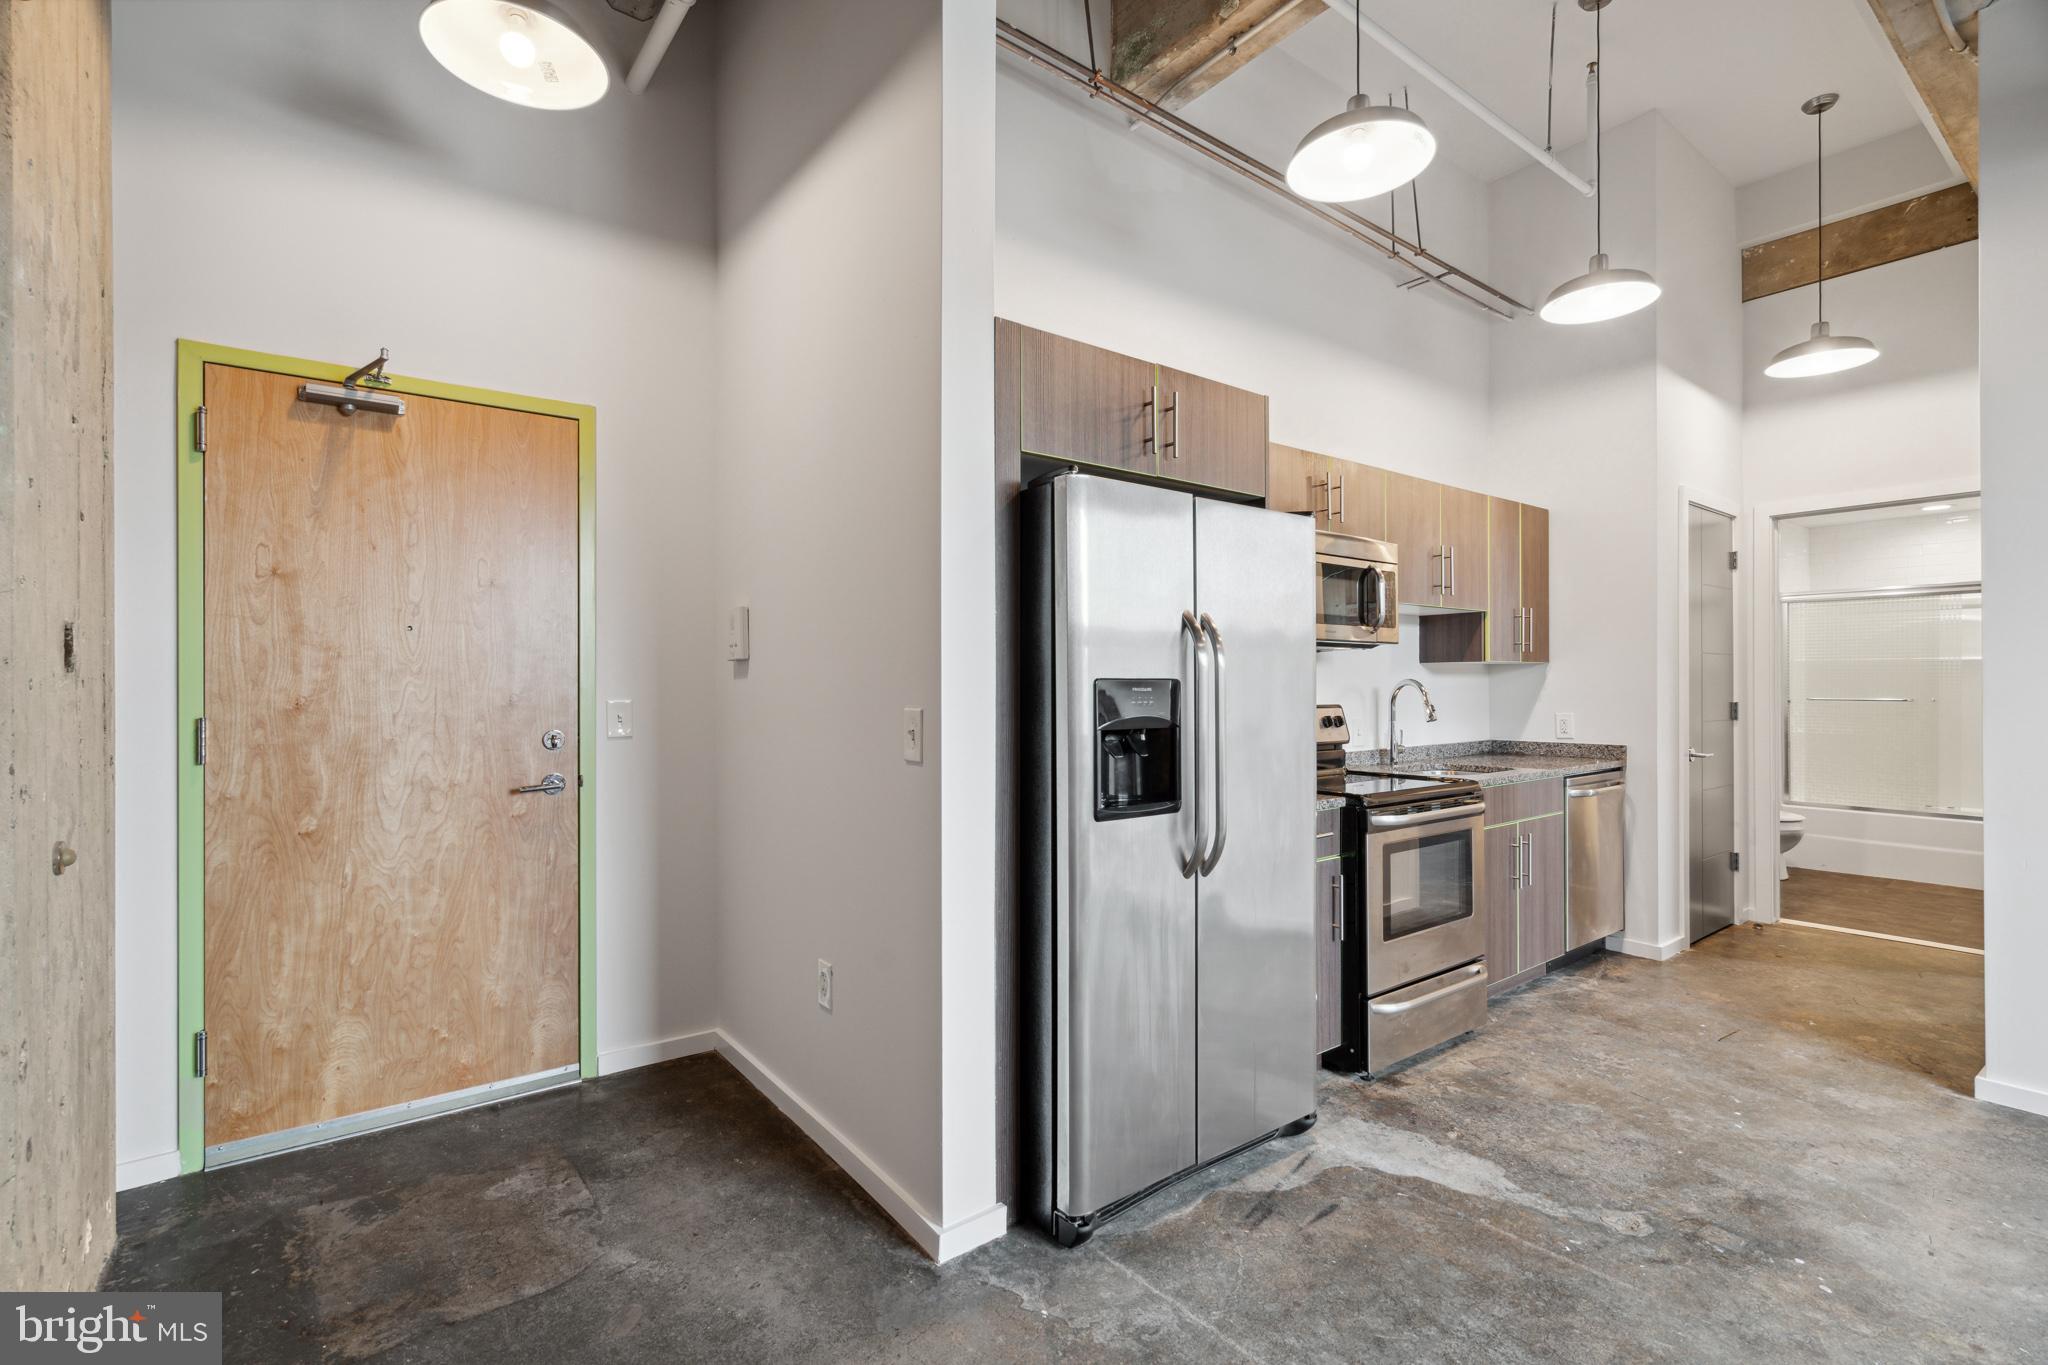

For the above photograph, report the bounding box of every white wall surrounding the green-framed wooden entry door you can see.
[115,0,719,1183]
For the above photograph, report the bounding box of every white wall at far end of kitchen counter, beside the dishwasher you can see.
[1491,113,1741,956]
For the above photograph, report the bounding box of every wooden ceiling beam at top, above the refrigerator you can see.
[1108,0,1323,108]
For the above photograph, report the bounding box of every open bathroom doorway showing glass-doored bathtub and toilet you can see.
[1757,493,1985,956]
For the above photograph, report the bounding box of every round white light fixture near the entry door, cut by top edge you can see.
[420,0,612,108]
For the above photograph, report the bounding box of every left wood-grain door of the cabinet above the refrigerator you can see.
[1018,327,1163,475]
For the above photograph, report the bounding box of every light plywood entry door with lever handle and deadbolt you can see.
[205,364,580,1148]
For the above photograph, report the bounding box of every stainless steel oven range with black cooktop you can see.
[1337,774,1487,1074]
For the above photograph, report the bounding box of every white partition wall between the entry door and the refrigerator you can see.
[713,0,1004,1254]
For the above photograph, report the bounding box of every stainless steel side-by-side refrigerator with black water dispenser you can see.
[1020,473,1315,1246]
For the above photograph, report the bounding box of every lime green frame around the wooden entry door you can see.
[174,340,598,1171]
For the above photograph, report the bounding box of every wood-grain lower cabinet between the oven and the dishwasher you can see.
[1481,780,1565,990]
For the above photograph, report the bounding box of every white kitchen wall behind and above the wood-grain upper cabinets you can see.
[995,56,1509,747]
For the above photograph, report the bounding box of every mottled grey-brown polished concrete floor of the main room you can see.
[109,927,2048,1365]
